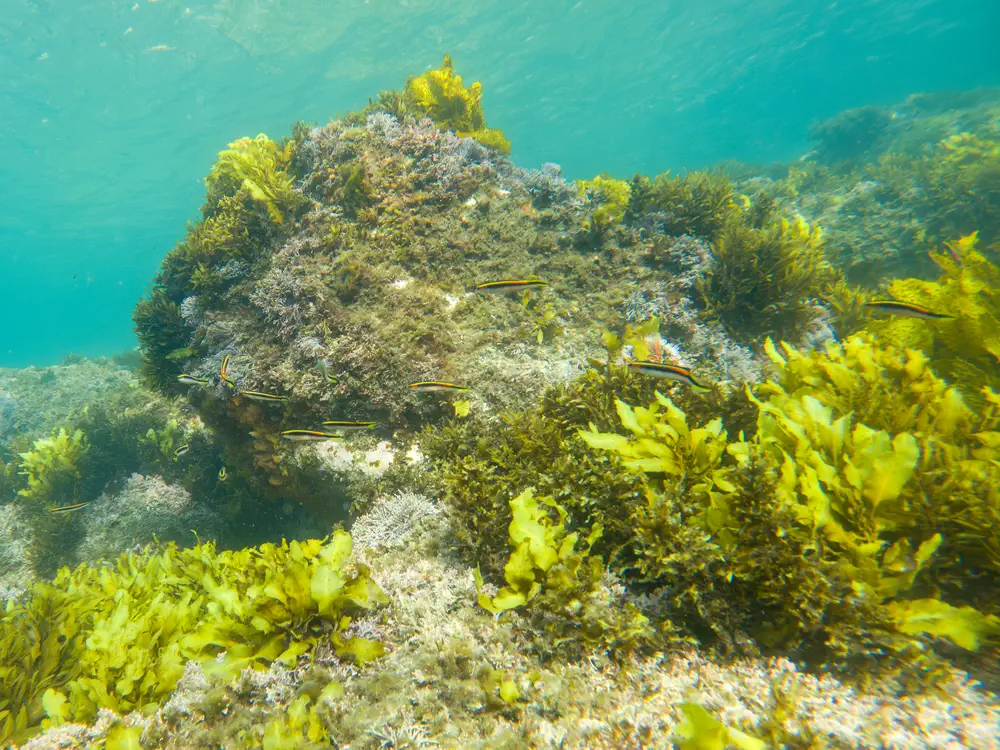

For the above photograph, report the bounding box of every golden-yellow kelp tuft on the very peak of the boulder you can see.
[403,55,510,154]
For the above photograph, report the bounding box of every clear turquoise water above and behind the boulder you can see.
[0,0,1000,366]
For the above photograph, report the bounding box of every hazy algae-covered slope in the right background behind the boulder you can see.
[747,88,1000,284]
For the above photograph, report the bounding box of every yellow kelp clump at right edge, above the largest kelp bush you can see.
[868,235,1000,396]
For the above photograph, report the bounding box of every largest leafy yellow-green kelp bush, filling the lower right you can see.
[580,336,1000,658]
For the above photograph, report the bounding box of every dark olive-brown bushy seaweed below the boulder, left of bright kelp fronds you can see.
[419,368,756,577]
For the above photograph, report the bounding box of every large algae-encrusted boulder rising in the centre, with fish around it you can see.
[136,95,848,520]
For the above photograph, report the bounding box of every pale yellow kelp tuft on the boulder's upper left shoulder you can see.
[205,133,299,224]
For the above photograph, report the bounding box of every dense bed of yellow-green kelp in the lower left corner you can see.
[0,531,386,744]
